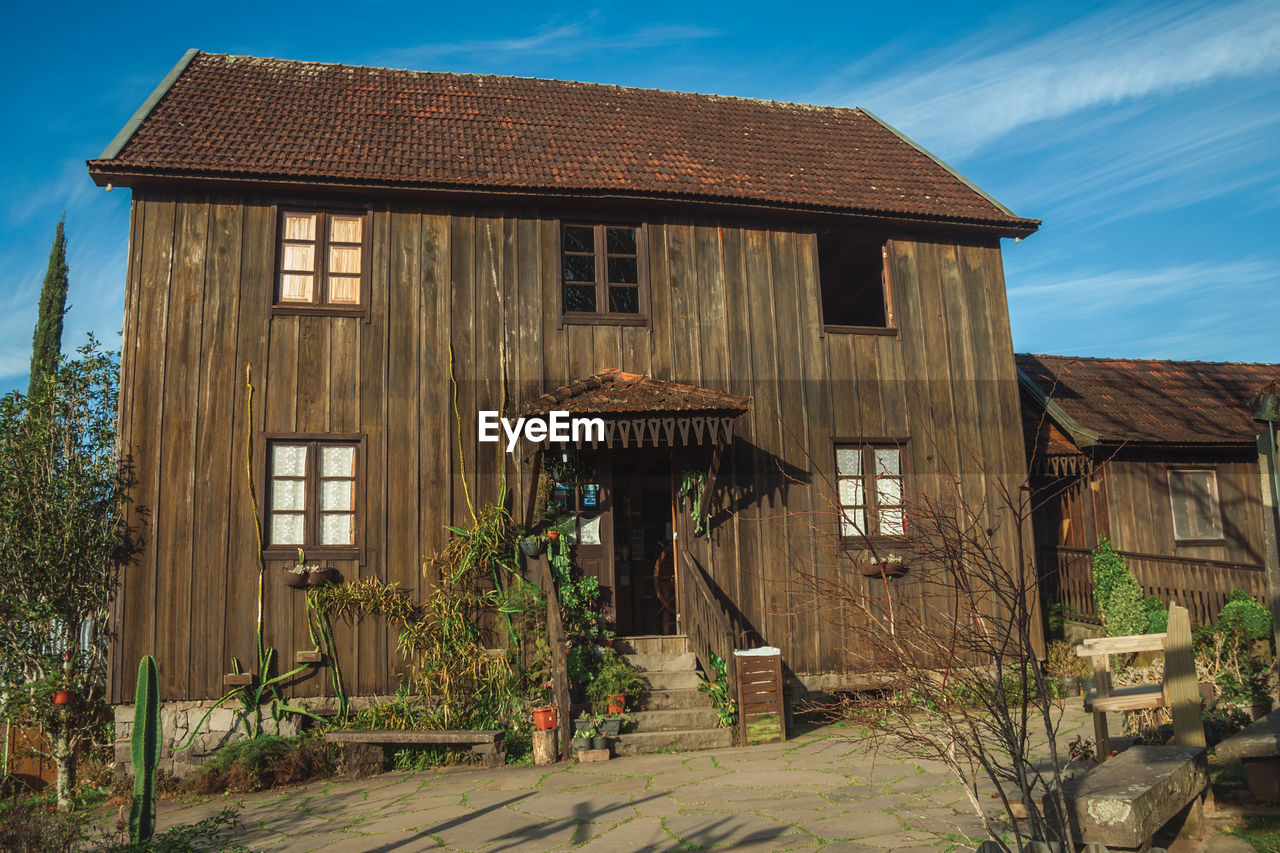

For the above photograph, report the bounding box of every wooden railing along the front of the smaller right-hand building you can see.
[1041,548,1267,624]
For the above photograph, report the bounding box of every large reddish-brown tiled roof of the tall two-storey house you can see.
[90,51,1039,236]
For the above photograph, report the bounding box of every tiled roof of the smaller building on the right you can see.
[1015,353,1280,444]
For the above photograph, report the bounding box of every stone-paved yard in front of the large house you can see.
[124,711,1203,853]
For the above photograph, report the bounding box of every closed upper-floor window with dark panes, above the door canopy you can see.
[561,223,648,325]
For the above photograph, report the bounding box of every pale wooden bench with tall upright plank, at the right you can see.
[1075,596,1204,761]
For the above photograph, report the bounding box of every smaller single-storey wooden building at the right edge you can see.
[1018,353,1280,622]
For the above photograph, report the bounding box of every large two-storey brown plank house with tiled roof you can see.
[88,51,1038,703]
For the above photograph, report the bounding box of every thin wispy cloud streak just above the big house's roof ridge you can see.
[375,15,718,67]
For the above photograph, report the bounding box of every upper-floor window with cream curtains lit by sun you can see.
[275,209,369,311]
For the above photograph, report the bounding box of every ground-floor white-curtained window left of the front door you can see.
[266,438,360,549]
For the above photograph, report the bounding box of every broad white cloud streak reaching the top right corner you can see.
[844,0,1280,158]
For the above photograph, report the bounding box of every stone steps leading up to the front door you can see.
[614,637,733,756]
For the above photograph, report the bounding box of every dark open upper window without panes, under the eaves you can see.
[818,232,896,334]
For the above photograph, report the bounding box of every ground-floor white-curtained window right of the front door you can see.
[836,444,906,539]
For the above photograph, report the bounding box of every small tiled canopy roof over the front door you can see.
[520,368,751,415]
